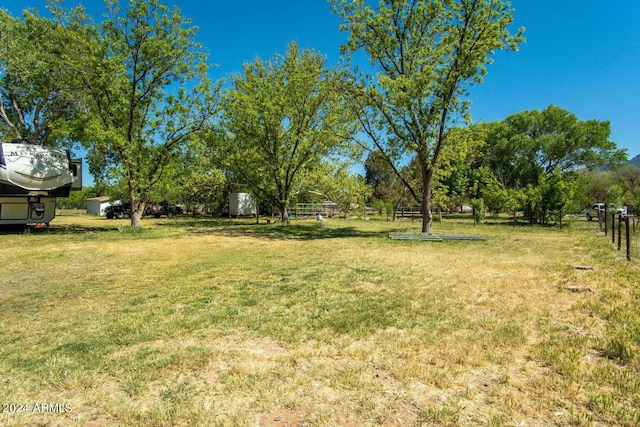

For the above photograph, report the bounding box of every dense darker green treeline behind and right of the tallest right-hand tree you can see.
[365,105,640,224]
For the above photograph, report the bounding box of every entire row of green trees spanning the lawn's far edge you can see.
[0,0,640,227]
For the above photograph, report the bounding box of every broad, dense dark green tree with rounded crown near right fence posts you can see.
[470,105,626,223]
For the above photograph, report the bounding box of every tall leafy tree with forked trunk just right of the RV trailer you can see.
[54,0,214,227]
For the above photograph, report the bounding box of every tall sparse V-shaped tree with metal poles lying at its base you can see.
[332,0,522,232]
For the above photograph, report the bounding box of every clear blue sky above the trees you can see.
[0,0,640,166]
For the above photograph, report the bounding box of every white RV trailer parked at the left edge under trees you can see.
[0,141,82,226]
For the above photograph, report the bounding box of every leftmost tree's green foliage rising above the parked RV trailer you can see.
[0,9,81,148]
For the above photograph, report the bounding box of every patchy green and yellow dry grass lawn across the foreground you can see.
[0,215,640,427]
